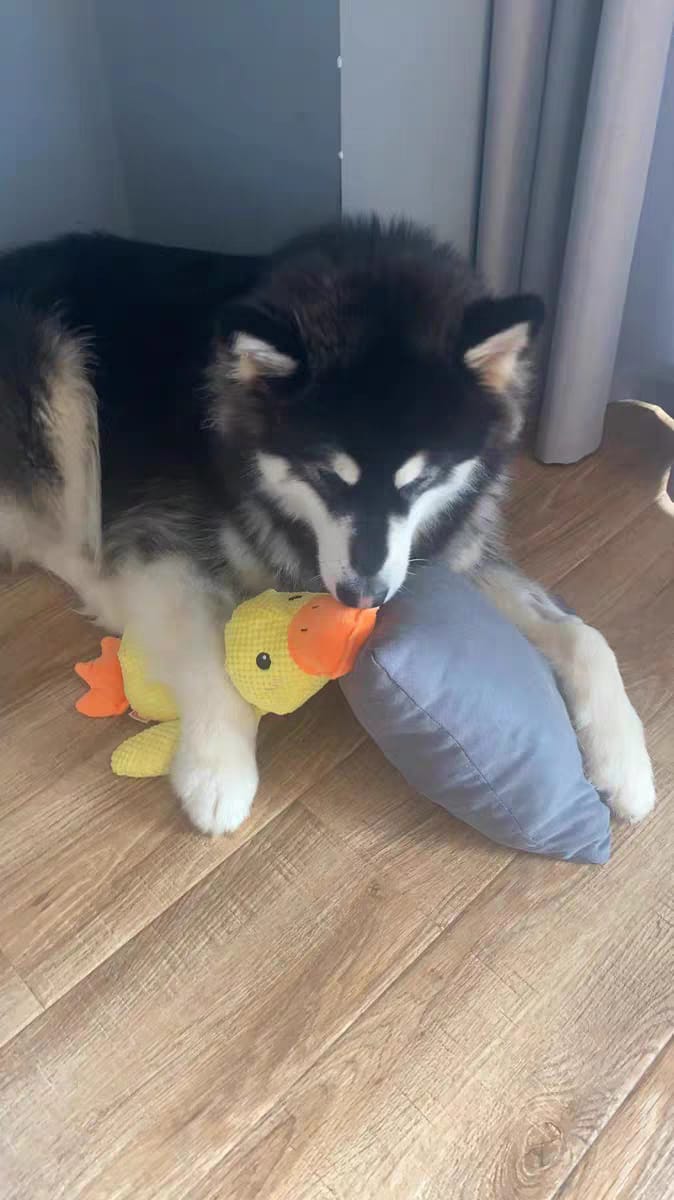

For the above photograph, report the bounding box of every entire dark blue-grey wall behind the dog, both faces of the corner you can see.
[0,0,339,251]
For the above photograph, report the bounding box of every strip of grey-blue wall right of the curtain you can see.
[613,38,674,414]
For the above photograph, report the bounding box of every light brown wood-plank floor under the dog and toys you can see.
[0,406,674,1200]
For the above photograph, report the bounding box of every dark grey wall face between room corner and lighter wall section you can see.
[97,0,339,251]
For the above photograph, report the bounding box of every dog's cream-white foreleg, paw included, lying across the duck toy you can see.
[112,557,258,834]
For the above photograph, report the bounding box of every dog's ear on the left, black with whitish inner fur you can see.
[219,305,303,386]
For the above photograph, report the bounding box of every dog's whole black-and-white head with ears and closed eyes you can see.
[211,223,542,607]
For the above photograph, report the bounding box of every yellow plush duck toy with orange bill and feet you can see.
[74,590,377,779]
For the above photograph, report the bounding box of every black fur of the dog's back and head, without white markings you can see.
[0,221,542,600]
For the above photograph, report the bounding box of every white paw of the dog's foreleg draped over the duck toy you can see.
[171,738,258,834]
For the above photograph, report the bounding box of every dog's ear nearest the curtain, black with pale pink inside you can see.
[458,294,544,394]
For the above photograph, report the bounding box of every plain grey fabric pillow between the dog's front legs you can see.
[341,565,610,863]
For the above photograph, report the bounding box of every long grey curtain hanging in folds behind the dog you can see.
[475,0,674,462]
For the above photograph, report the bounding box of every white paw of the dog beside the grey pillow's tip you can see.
[580,696,655,822]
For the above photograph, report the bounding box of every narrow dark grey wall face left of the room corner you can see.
[0,0,127,246]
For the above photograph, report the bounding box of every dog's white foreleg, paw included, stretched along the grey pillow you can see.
[473,562,655,821]
